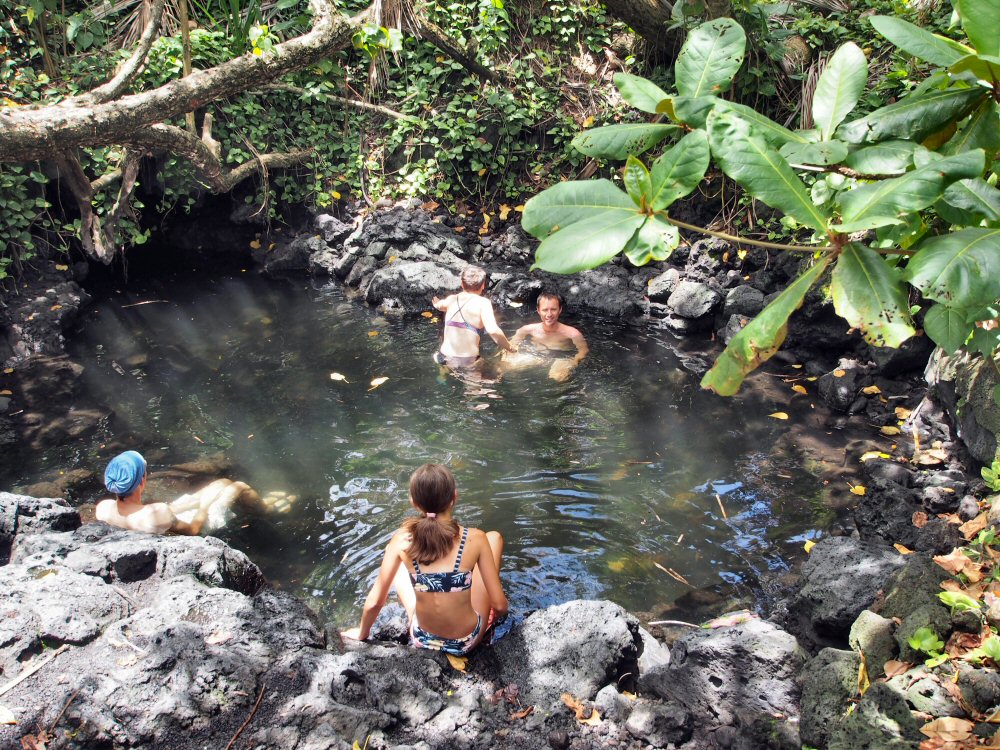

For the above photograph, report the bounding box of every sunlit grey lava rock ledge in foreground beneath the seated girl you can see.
[0,493,807,750]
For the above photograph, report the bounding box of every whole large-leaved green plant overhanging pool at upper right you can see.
[523,0,1000,395]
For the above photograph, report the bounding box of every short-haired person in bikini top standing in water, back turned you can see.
[432,266,517,368]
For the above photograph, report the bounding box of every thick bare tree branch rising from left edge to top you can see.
[0,0,371,163]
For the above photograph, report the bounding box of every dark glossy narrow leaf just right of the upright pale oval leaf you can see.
[837,87,985,143]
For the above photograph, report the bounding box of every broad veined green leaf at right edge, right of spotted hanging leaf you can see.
[904,229,1000,308]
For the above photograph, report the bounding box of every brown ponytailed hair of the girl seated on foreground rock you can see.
[403,464,458,565]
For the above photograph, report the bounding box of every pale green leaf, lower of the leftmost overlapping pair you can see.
[532,211,646,273]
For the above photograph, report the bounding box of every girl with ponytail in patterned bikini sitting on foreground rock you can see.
[342,464,507,655]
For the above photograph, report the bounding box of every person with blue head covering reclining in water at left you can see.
[94,451,263,536]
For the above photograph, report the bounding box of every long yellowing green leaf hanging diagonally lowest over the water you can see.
[701,255,830,396]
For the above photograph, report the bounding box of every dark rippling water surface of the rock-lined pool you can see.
[22,277,832,621]
